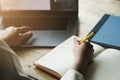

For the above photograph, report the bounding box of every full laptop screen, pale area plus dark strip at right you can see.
[0,0,77,11]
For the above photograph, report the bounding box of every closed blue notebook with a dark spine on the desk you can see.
[89,14,120,49]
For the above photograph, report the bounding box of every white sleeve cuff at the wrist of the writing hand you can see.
[60,69,84,80]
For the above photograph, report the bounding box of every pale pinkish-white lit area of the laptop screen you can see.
[1,0,51,10]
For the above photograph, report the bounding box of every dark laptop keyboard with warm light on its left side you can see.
[2,17,68,30]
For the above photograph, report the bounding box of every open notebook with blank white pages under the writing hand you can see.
[34,36,120,80]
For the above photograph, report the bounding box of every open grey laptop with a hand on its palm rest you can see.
[0,0,78,47]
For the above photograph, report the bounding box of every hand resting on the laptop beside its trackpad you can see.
[0,26,32,46]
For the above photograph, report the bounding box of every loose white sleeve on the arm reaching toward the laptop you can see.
[0,40,32,80]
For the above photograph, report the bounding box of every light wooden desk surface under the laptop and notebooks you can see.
[15,0,120,80]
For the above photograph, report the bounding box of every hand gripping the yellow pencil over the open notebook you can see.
[73,38,94,74]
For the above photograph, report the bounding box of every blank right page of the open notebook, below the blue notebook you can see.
[87,49,120,80]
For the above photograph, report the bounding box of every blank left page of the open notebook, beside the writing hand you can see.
[36,36,74,75]
